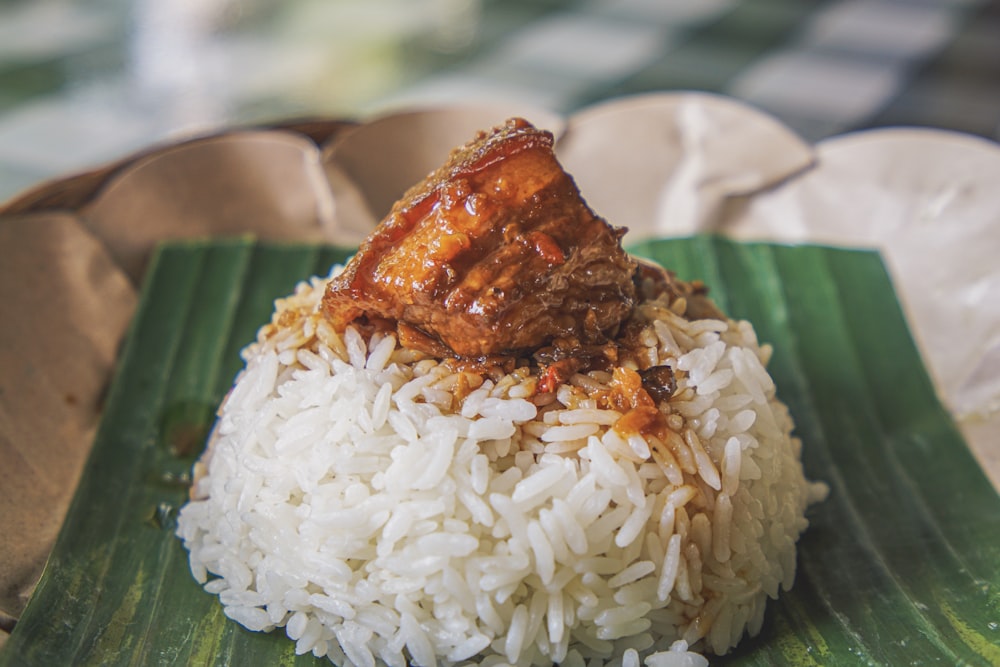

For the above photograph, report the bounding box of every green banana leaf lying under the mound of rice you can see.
[0,237,1000,667]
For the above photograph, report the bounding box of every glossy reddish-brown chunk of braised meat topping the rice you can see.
[323,119,636,360]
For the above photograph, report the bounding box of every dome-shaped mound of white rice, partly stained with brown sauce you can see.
[178,268,824,667]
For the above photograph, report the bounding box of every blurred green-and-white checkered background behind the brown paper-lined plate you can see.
[0,0,1000,202]
